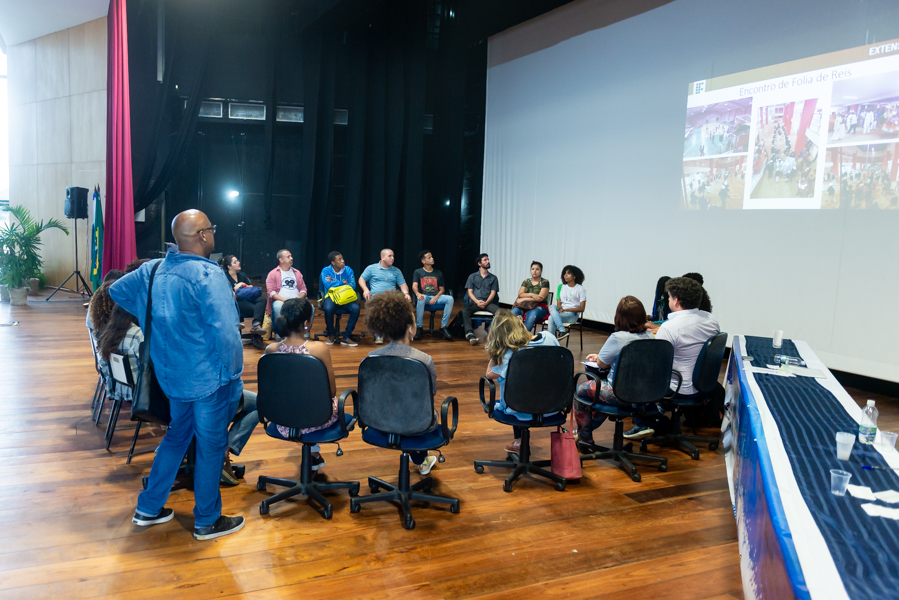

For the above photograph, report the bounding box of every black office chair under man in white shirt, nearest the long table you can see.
[640,332,727,460]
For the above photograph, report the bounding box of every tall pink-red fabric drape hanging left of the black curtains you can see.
[103,0,137,275]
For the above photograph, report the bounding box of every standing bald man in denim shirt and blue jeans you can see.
[109,210,244,540]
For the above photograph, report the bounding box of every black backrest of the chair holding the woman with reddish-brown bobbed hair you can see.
[612,340,674,404]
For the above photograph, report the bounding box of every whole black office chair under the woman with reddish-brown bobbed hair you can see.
[578,340,680,481]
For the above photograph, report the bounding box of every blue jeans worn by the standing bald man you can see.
[137,379,243,527]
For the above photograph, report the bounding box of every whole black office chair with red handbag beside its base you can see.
[474,346,576,492]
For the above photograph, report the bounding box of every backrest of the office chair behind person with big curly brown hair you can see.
[357,356,434,435]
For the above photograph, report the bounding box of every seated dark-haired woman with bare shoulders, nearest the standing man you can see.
[265,298,337,471]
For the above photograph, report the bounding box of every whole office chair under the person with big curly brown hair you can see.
[350,356,459,529]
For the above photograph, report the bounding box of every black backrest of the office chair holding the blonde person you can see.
[503,346,574,415]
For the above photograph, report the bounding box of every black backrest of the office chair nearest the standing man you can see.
[256,352,333,429]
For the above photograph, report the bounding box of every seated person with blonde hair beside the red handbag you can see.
[484,308,559,454]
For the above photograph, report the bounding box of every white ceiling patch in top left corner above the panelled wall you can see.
[0,0,109,47]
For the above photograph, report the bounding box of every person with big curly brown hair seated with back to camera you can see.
[365,291,442,475]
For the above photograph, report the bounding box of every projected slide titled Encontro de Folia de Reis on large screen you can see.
[681,41,899,210]
